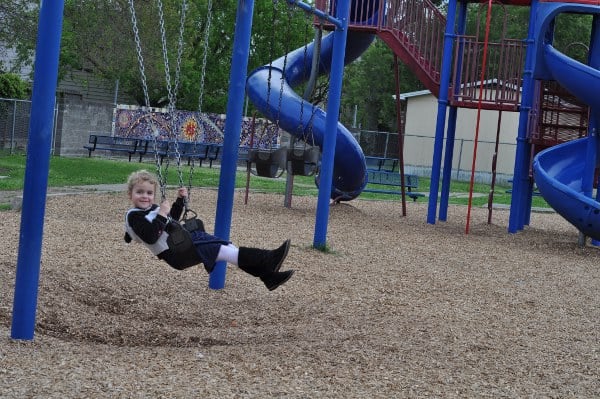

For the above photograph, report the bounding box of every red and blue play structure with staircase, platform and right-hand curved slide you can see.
[302,0,600,238]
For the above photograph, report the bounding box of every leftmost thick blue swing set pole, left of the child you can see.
[11,0,64,340]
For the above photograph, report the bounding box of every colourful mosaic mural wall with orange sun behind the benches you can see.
[113,105,280,148]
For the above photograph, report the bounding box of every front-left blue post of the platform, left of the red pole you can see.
[427,0,456,224]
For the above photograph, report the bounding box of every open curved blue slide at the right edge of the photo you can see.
[533,44,600,240]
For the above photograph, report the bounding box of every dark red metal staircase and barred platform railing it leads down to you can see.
[316,0,525,111]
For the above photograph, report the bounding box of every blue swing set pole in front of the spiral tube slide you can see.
[313,0,350,248]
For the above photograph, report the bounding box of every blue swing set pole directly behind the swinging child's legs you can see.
[208,0,254,290]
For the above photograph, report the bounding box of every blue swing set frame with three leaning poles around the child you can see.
[11,0,350,340]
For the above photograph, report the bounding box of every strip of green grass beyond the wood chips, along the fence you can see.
[0,154,548,210]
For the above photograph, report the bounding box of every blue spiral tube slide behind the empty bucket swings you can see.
[246,31,374,201]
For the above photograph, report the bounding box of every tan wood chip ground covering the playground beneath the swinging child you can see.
[0,189,600,398]
